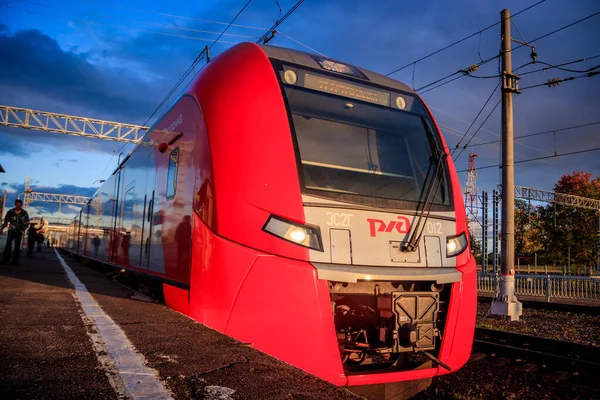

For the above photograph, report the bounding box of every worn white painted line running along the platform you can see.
[54,249,172,400]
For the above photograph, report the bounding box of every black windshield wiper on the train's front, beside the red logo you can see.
[400,119,448,252]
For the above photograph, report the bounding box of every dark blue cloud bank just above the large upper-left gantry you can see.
[0,30,159,121]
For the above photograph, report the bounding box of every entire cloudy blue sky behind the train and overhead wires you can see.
[0,0,600,219]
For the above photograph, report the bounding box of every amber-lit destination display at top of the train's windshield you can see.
[304,73,390,106]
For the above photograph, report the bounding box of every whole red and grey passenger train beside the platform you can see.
[63,43,476,386]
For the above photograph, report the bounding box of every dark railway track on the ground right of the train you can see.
[473,328,600,374]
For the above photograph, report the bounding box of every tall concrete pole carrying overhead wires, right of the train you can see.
[492,9,522,321]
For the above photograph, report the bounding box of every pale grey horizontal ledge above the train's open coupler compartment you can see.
[312,263,462,283]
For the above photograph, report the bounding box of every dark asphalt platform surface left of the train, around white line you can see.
[0,249,360,400]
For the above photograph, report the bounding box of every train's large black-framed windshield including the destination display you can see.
[275,64,453,211]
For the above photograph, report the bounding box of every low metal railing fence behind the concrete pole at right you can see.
[477,274,600,301]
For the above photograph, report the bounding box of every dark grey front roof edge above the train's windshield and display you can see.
[257,44,416,94]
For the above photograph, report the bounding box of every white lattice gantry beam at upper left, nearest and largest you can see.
[0,105,149,143]
